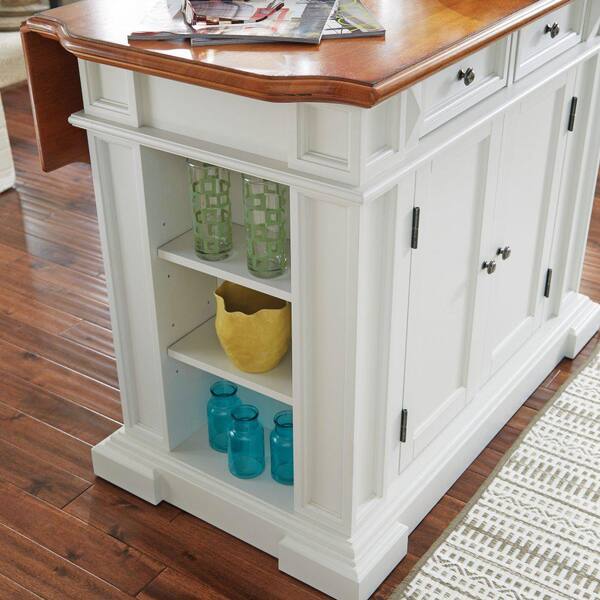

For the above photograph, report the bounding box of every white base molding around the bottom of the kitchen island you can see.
[92,294,600,600]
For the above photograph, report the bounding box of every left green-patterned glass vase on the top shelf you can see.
[188,160,233,260]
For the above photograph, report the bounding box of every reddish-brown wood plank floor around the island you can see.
[0,86,600,600]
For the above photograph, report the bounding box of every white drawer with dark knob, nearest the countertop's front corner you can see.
[421,37,510,136]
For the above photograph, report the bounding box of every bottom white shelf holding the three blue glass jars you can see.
[170,423,294,512]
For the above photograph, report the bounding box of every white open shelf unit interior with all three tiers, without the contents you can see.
[141,147,294,512]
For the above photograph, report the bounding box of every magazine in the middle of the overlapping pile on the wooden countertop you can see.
[185,0,337,45]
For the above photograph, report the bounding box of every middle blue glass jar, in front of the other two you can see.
[228,404,265,479]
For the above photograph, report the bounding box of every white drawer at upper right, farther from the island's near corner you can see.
[515,0,585,80]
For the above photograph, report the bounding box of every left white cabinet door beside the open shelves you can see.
[400,122,501,469]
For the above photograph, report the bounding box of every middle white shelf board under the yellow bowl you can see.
[168,318,292,406]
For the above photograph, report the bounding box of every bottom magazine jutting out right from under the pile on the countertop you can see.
[192,0,385,46]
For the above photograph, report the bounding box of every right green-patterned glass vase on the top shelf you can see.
[242,175,290,278]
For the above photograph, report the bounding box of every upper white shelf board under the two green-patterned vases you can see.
[158,224,292,302]
